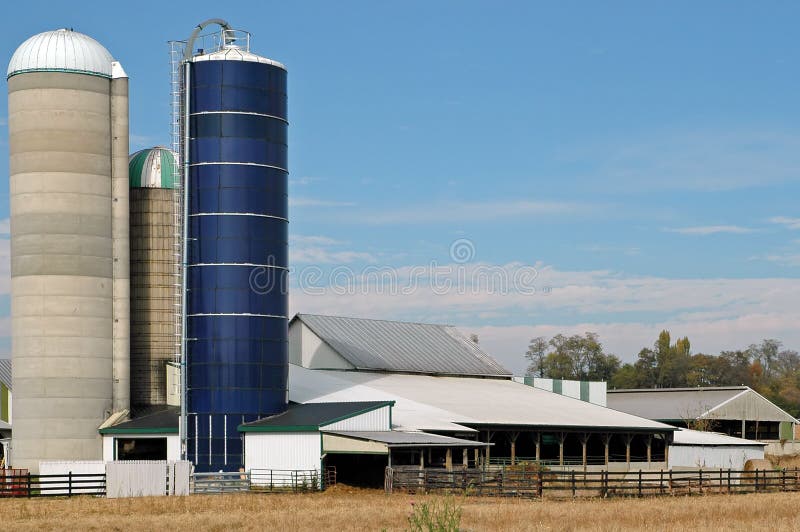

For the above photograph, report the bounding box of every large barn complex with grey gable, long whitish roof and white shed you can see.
[239,314,675,484]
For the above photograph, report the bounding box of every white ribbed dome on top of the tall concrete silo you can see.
[7,29,118,78]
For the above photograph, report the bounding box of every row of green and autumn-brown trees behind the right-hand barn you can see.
[525,331,800,417]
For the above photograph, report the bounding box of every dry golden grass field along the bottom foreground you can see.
[0,487,800,532]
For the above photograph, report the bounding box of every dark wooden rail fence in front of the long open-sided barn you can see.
[384,466,800,498]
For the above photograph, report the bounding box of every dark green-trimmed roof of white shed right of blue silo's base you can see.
[239,401,394,432]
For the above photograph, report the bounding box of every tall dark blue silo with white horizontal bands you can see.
[184,26,288,471]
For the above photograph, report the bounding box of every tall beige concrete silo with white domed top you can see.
[8,29,130,472]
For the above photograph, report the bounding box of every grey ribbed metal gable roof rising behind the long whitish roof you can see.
[292,314,511,377]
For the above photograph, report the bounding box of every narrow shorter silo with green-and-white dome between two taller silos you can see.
[129,147,177,409]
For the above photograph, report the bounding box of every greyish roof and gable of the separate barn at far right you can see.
[607,386,797,423]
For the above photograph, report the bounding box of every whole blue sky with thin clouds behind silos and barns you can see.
[0,1,800,371]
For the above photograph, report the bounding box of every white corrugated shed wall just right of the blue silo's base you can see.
[244,432,321,471]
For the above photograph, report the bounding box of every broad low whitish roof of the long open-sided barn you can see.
[289,364,675,432]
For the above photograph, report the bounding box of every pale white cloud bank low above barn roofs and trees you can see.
[290,263,800,371]
